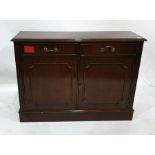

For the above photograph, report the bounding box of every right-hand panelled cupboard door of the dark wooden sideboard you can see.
[79,57,134,109]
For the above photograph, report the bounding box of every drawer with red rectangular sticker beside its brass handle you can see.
[22,43,76,56]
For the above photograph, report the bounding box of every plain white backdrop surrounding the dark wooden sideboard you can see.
[0,20,155,134]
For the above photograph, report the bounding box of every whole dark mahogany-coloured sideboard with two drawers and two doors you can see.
[12,31,146,122]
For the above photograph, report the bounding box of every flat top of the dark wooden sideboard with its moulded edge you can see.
[11,31,146,42]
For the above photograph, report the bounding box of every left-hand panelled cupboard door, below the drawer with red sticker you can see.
[23,57,77,110]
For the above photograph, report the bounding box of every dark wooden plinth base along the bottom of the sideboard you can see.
[19,110,134,122]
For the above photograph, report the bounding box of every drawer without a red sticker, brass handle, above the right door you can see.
[81,43,137,55]
